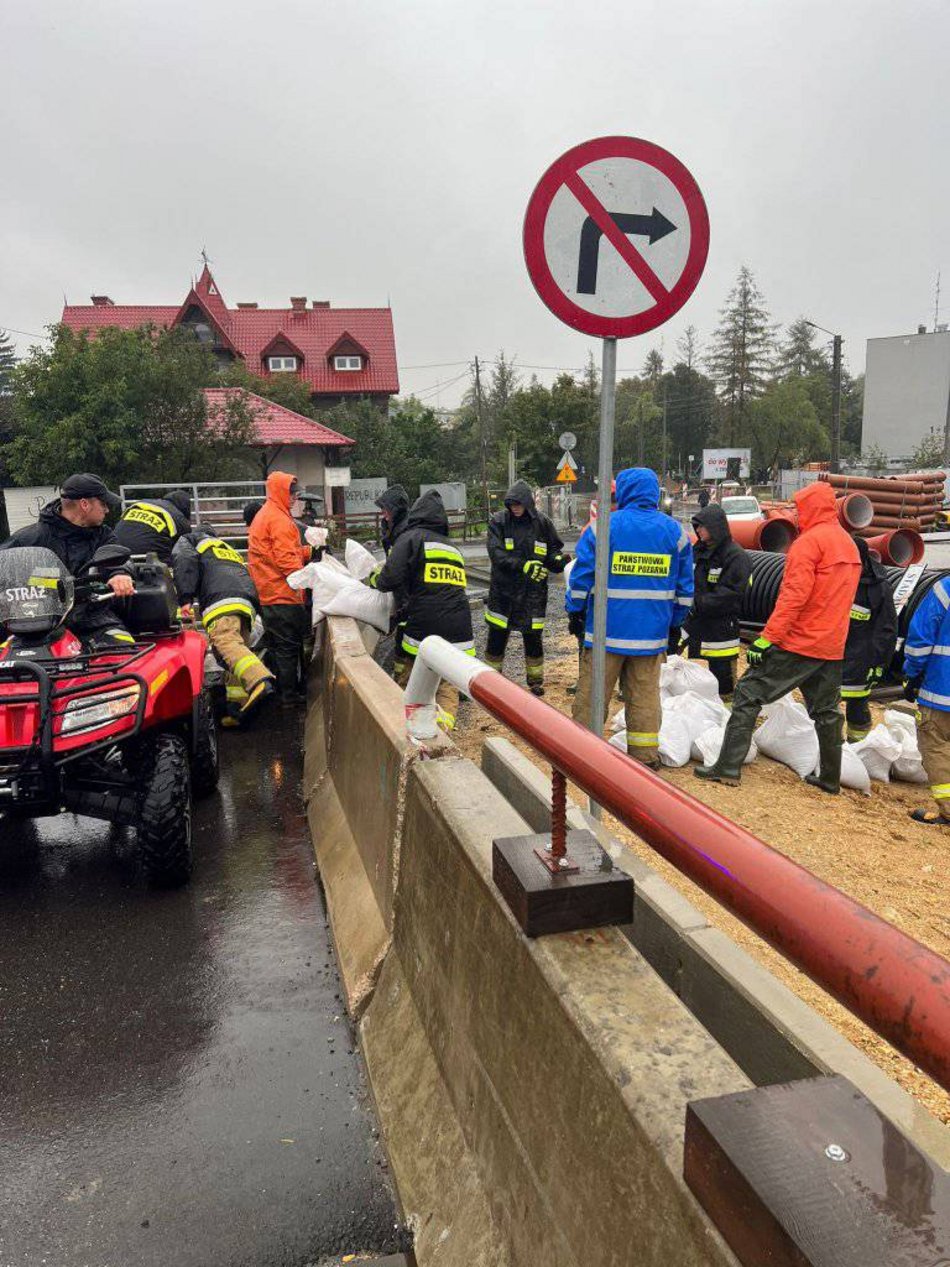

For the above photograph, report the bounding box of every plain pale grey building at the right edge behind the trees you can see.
[861,326,950,459]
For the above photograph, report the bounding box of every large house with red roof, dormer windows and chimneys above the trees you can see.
[62,264,399,407]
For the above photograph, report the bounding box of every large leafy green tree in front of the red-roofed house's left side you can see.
[5,326,255,484]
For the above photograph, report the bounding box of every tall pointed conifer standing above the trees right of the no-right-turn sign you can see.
[706,265,774,447]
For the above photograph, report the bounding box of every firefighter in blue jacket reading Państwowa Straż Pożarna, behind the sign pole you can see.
[565,466,693,769]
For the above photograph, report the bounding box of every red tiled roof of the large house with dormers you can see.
[62,266,399,395]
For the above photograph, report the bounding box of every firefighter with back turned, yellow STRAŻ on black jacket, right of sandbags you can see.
[367,489,475,730]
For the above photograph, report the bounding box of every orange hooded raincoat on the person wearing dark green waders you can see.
[761,481,861,660]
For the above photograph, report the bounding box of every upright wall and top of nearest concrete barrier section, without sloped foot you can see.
[395,761,749,1267]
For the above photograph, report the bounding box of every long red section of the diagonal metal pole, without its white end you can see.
[469,673,950,1091]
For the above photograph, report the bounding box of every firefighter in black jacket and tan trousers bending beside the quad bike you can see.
[171,528,274,725]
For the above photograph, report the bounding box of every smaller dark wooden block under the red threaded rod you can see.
[491,831,633,938]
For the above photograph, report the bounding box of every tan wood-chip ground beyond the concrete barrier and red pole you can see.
[453,636,950,1124]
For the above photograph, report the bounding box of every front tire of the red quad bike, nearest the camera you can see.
[136,735,191,888]
